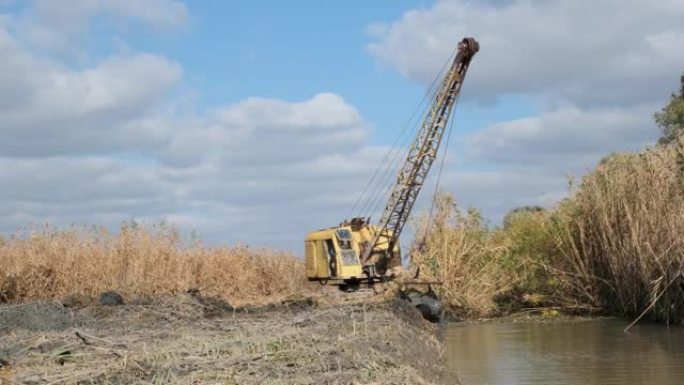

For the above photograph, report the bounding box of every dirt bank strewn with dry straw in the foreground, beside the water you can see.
[0,295,458,384]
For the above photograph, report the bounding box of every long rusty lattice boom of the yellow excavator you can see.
[361,38,480,264]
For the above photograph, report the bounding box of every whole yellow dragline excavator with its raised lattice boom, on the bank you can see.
[304,38,480,290]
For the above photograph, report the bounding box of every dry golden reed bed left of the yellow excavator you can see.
[0,225,308,306]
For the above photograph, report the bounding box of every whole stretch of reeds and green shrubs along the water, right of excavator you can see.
[415,139,684,324]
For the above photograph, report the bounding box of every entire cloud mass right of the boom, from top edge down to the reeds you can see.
[367,0,684,218]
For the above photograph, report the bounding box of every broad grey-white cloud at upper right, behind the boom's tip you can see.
[368,0,684,106]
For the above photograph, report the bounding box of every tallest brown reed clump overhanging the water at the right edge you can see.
[555,139,684,324]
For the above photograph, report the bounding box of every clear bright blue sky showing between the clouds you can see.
[103,0,537,144]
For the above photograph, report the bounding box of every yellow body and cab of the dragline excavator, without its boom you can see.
[304,225,401,284]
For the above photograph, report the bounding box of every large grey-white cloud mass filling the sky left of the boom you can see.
[0,3,382,250]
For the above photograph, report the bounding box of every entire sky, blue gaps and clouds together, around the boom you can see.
[0,0,684,252]
